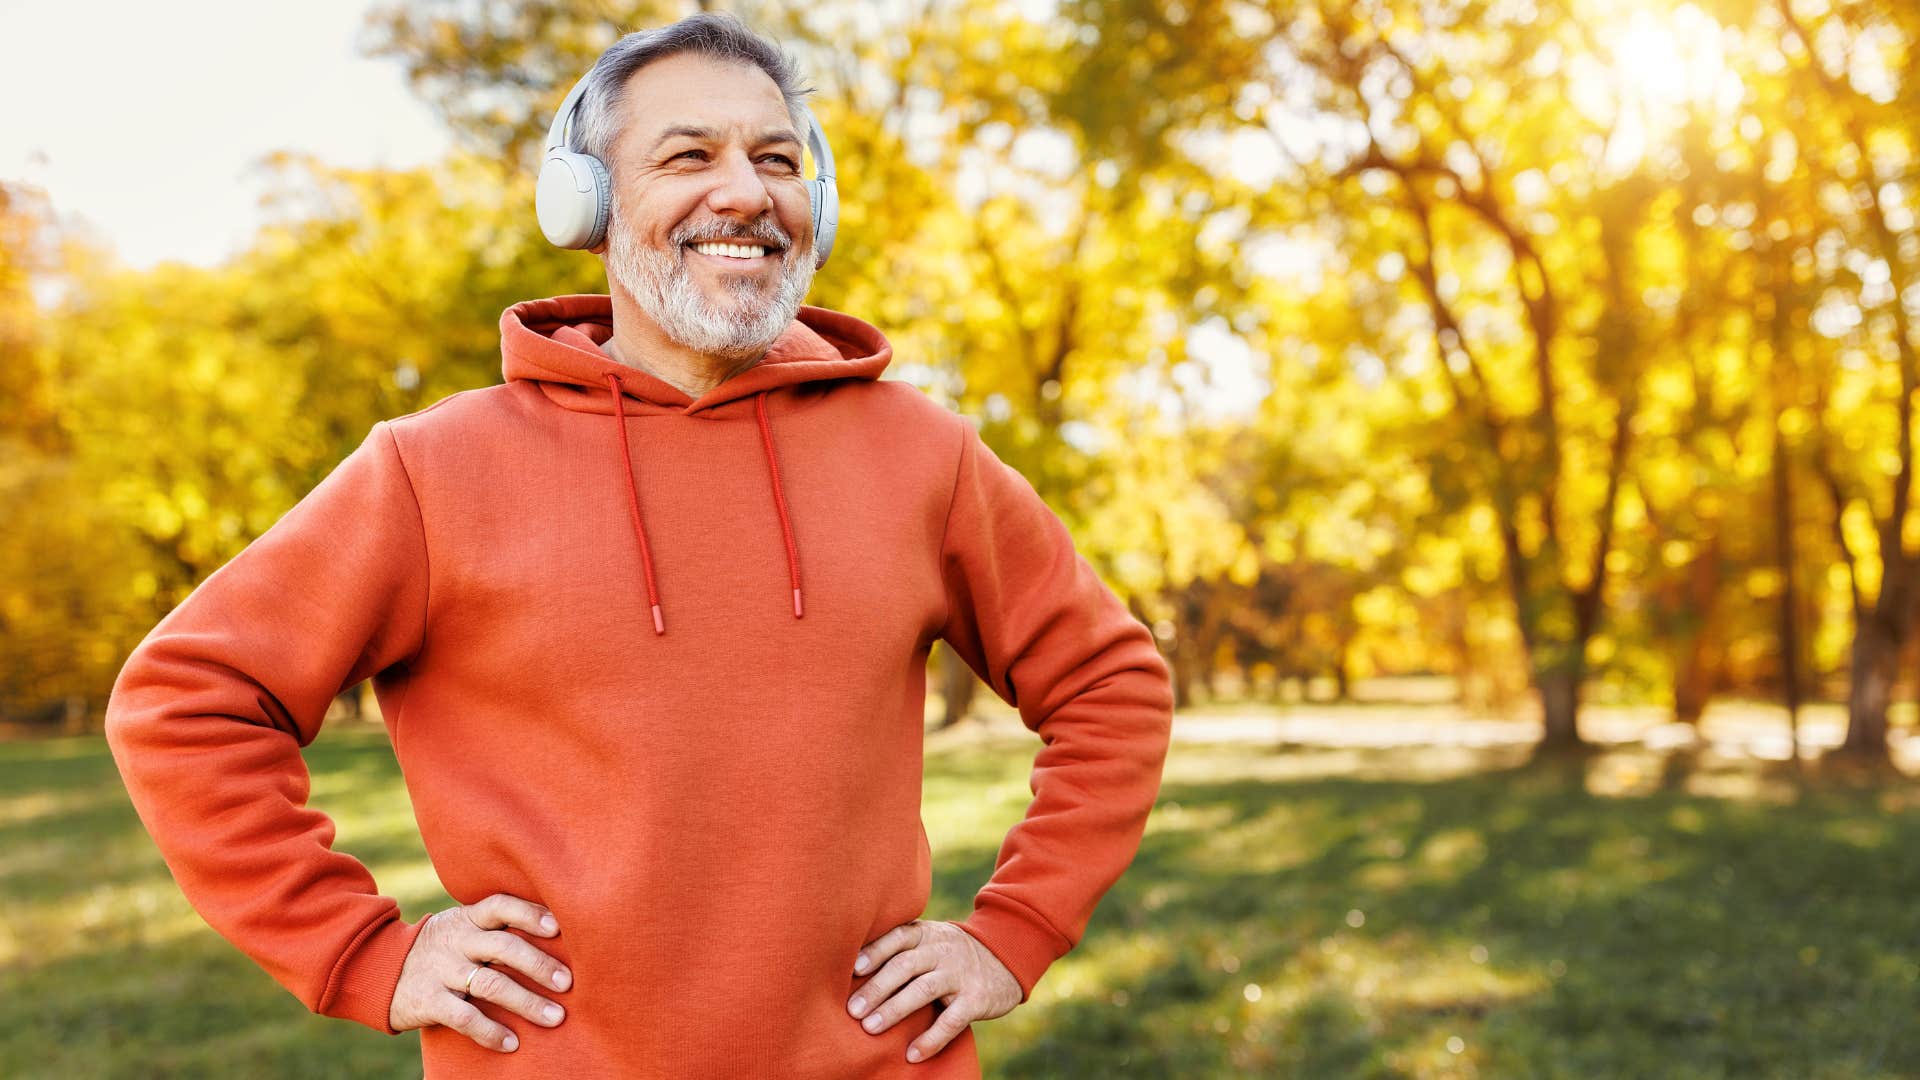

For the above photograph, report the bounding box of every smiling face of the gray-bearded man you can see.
[605,54,814,359]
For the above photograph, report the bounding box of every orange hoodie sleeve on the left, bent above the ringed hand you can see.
[106,421,426,1034]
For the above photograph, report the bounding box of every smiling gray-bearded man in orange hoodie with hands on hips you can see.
[108,15,1171,1078]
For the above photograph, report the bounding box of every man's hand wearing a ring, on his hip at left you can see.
[388,892,574,1053]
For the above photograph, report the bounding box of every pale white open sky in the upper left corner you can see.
[0,0,451,269]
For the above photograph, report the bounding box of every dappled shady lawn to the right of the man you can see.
[941,748,1920,1078]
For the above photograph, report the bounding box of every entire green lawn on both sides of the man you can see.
[0,724,1920,1078]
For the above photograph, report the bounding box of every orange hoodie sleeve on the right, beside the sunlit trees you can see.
[941,423,1173,1001]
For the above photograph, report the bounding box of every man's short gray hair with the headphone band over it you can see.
[566,12,814,173]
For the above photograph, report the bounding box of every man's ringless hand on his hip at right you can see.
[847,919,1023,1061]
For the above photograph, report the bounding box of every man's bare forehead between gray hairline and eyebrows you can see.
[622,52,793,150]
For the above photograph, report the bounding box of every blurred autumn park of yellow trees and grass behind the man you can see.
[0,0,1920,1078]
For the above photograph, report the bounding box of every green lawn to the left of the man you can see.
[0,728,440,1078]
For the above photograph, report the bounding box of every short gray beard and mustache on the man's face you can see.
[607,198,814,363]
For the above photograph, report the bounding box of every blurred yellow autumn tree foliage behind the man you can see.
[0,0,1920,722]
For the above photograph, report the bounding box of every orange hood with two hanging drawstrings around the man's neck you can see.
[499,294,893,634]
